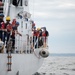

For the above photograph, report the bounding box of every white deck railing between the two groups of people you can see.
[15,35,33,54]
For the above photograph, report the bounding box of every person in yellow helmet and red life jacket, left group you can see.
[5,16,12,48]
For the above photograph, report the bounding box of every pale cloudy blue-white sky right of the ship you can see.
[29,0,75,53]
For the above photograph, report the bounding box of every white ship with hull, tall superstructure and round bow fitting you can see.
[0,0,49,75]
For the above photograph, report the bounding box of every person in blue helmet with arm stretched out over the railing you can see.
[11,22,22,48]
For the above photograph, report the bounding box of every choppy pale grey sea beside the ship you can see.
[34,54,75,75]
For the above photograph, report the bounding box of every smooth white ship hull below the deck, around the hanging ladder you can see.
[0,51,43,75]
